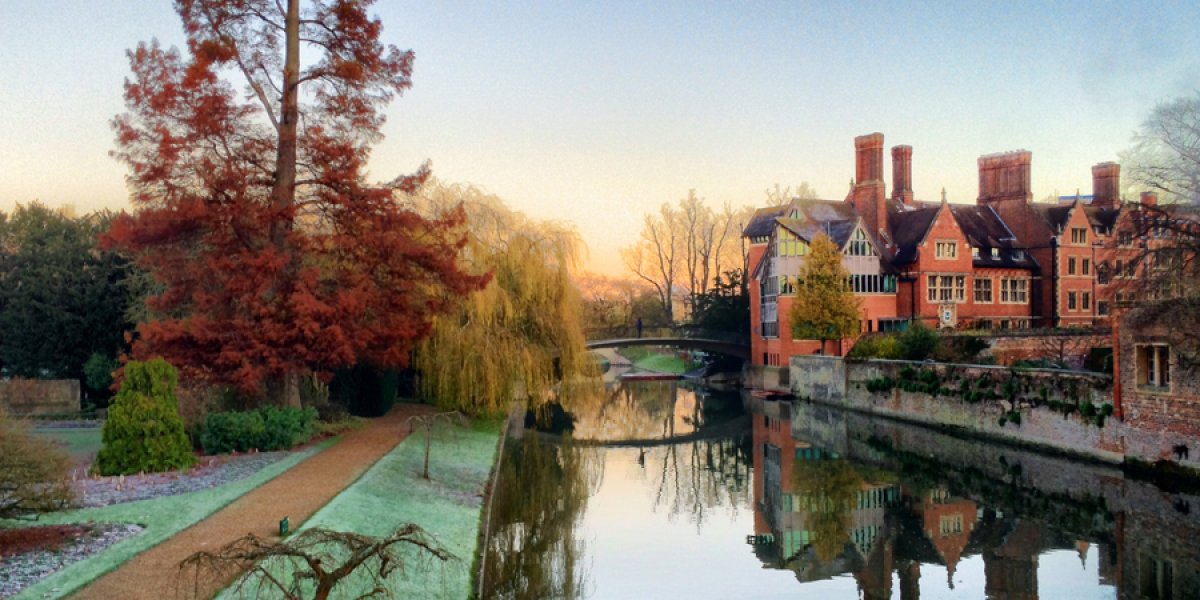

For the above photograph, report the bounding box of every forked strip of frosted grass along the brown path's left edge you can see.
[8,440,334,599]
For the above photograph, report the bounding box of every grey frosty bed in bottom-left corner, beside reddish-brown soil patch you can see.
[0,523,143,598]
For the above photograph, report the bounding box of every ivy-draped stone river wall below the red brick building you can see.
[786,356,1200,479]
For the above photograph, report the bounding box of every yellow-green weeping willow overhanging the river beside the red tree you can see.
[410,184,592,415]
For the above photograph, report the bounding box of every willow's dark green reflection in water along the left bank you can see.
[484,436,601,600]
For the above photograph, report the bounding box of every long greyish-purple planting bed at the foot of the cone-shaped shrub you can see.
[76,451,288,508]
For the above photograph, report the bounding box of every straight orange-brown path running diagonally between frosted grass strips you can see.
[74,404,433,600]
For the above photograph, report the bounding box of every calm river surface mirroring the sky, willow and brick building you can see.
[485,382,1200,600]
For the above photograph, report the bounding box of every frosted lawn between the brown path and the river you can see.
[220,421,500,599]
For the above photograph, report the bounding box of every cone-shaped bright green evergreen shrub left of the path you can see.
[96,359,196,475]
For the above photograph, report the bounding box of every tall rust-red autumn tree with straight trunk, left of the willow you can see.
[107,0,486,401]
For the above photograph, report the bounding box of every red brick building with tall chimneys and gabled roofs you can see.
[743,133,1169,366]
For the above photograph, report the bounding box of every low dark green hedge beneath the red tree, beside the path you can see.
[200,407,317,454]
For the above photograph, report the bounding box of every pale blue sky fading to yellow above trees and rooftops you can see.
[0,0,1200,275]
